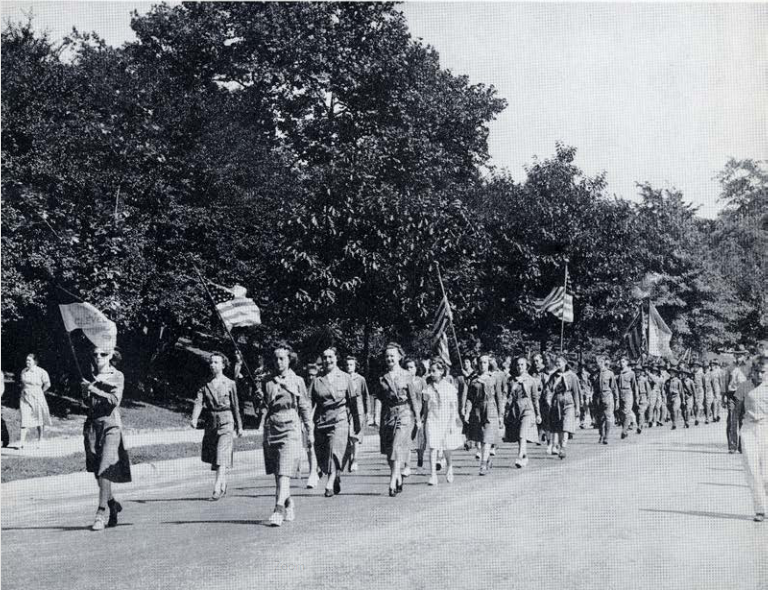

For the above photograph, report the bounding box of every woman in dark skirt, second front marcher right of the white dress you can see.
[504,356,541,469]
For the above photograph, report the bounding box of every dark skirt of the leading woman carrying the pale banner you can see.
[83,420,131,483]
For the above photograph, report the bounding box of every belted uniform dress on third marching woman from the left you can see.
[264,370,312,476]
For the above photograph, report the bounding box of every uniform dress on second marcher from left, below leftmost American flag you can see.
[195,375,243,470]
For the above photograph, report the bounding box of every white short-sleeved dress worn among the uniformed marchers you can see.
[422,379,464,451]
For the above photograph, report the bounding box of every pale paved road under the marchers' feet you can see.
[2,424,768,590]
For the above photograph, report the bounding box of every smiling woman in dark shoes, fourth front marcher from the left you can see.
[309,347,364,498]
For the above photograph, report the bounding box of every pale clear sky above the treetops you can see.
[2,1,768,217]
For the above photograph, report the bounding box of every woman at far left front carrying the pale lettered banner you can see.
[82,348,131,531]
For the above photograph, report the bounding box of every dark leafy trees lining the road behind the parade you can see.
[2,3,768,396]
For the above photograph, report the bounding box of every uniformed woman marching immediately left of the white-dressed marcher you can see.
[374,342,421,497]
